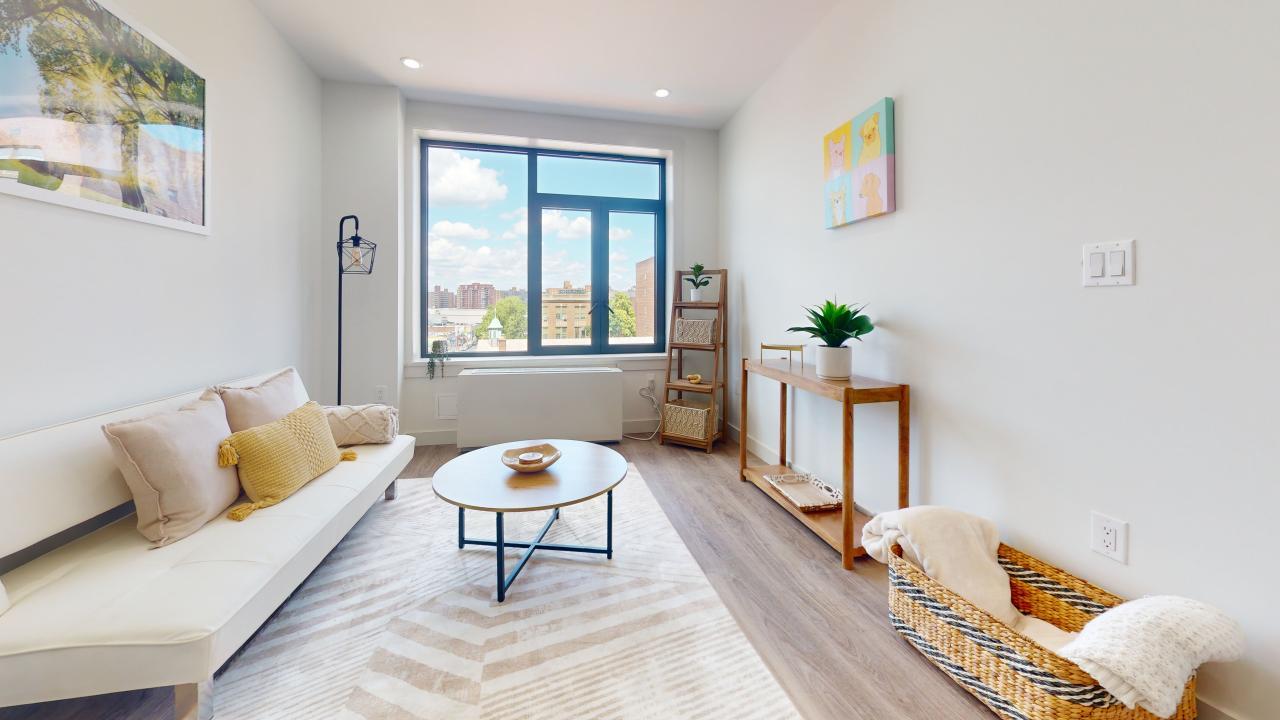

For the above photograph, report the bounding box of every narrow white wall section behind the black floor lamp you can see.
[314,81,404,405]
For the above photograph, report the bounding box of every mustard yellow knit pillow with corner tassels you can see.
[218,401,356,520]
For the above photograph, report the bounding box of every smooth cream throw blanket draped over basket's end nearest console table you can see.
[863,505,1074,651]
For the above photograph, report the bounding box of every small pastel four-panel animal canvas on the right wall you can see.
[822,97,896,228]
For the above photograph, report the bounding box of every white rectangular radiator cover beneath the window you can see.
[457,368,622,447]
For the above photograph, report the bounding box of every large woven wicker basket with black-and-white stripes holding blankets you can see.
[888,544,1196,720]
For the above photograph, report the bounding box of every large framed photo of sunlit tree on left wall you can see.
[0,0,209,233]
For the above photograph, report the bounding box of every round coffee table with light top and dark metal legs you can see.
[431,439,627,602]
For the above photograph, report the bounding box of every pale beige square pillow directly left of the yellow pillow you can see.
[102,391,239,544]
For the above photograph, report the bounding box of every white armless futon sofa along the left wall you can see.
[0,373,413,720]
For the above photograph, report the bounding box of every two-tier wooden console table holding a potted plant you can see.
[737,357,911,570]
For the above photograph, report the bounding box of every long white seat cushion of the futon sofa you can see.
[0,436,413,706]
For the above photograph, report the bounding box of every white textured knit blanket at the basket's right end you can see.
[1057,596,1244,717]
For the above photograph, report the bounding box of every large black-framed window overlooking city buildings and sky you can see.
[420,140,667,356]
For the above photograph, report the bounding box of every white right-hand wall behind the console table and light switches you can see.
[719,0,1280,720]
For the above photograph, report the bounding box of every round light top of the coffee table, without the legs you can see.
[431,439,627,512]
